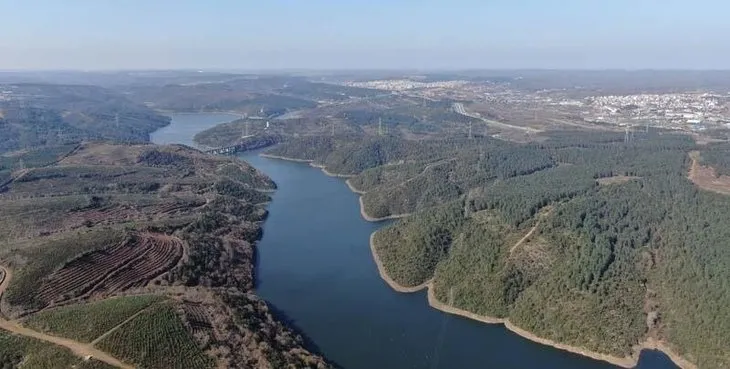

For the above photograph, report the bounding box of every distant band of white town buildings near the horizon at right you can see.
[345,79,730,131]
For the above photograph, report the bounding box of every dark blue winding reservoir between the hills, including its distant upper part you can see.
[151,114,676,369]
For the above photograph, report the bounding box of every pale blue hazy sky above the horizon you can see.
[0,0,730,69]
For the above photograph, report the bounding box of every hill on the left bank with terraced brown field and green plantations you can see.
[0,143,328,368]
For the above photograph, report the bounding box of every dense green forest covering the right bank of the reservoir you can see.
[271,132,730,368]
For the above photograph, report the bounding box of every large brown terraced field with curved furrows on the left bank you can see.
[38,233,183,304]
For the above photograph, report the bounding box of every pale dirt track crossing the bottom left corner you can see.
[0,266,134,369]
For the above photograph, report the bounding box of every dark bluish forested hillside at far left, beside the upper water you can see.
[0,84,170,152]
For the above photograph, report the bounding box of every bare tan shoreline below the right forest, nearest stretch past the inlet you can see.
[370,231,698,369]
